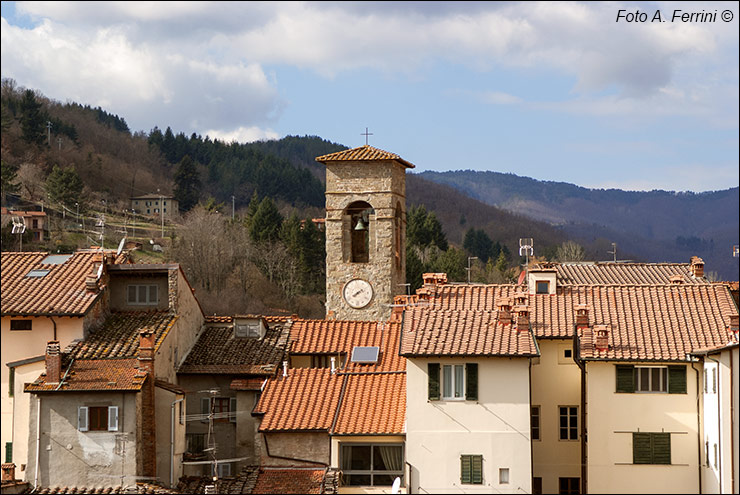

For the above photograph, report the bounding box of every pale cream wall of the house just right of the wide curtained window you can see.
[406,358,532,493]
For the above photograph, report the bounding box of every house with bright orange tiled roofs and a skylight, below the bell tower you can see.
[253,319,406,493]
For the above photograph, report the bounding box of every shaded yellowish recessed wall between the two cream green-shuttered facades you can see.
[532,339,581,493]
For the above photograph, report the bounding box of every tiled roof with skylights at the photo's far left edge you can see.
[0,251,107,316]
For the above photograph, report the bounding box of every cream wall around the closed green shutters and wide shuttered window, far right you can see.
[586,362,701,493]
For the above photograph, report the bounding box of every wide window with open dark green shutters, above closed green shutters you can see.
[616,364,686,394]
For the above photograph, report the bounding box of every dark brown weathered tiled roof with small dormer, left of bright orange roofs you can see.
[178,324,288,375]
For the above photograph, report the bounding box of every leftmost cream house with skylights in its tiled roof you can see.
[0,250,128,478]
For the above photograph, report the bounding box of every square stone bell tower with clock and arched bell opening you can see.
[316,145,414,321]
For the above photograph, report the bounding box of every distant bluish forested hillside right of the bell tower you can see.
[420,170,740,280]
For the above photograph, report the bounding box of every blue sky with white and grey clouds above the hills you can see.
[0,1,740,192]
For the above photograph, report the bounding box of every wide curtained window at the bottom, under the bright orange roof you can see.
[339,443,404,486]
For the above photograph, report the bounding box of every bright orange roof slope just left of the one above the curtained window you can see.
[254,368,344,431]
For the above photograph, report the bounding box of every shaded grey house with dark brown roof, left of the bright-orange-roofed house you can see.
[177,315,292,478]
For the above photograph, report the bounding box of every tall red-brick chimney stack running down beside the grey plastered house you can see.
[136,328,157,478]
